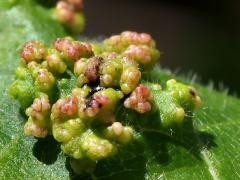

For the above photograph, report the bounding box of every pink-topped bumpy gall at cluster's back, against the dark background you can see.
[103,31,160,71]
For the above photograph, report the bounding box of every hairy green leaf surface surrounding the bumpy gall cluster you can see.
[0,0,240,179]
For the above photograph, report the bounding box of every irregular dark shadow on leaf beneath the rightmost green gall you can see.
[132,106,217,166]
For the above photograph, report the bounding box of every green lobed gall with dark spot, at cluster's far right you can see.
[153,79,201,128]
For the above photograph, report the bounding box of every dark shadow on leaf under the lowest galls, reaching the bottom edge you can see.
[66,140,146,180]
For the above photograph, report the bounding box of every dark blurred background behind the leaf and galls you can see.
[85,0,240,95]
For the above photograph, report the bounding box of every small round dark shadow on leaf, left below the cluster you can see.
[33,136,61,165]
